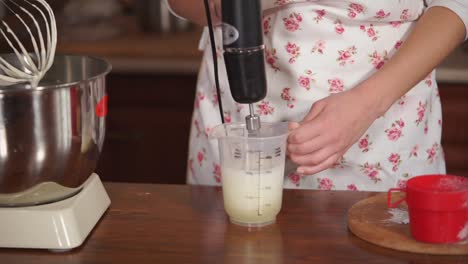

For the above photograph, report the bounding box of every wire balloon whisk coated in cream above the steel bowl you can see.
[0,0,57,87]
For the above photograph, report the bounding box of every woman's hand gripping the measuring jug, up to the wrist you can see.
[288,86,381,175]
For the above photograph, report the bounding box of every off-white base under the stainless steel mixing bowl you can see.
[0,173,110,251]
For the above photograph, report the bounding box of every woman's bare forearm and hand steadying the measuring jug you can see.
[288,6,466,174]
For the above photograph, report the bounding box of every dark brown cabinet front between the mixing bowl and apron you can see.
[96,74,196,184]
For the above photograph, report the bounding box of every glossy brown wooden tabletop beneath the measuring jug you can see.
[0,183,468,264]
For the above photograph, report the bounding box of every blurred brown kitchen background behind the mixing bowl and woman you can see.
[0,0,468,184]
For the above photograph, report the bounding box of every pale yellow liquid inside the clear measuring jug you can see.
[221,166,284,226]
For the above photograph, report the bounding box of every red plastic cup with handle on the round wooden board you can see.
[387,175,468,243]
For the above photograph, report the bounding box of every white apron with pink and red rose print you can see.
[187,0,445,191]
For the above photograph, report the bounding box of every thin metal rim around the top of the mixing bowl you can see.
[0,54,112,94]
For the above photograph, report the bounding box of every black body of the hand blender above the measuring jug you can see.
[222,0,267,104]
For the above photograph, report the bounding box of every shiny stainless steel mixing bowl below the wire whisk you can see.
[0,54,111,207]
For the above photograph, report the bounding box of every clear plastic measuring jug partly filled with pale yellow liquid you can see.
[212,122,288,227]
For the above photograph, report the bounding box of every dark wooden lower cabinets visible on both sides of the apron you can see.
[97,74,468,184]
